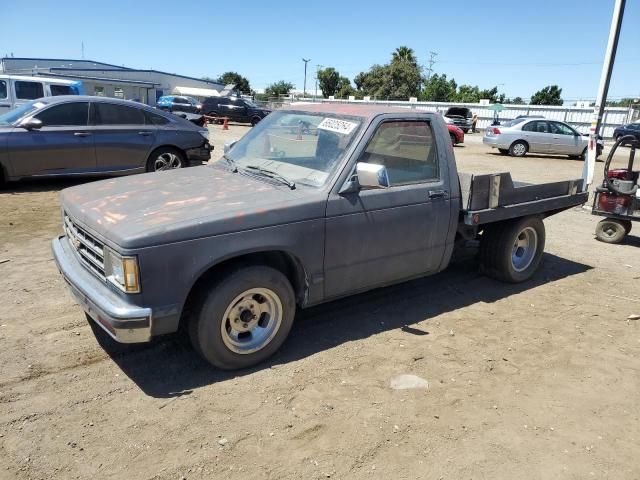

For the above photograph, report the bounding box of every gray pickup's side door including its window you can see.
[324,119,451,298]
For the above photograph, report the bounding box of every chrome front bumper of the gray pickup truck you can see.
[51,236,152,343]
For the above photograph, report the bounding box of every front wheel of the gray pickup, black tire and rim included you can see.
[189,266,296,370]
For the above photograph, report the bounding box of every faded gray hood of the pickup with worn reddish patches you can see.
[61,165,327,249]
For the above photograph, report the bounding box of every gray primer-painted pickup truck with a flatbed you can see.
[53,104,587,369]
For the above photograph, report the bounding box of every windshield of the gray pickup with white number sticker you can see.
[226,111,361,188]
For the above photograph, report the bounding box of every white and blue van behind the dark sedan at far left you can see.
[0,75,84,114]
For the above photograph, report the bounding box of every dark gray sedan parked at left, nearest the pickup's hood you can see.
[0,96,211,184]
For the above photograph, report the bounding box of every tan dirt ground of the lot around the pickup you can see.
[0,125,640,480]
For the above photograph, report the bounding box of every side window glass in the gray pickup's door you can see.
[360,121,439,186]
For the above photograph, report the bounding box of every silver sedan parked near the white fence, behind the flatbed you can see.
[482,118,604,158]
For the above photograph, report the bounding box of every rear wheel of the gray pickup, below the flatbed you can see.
[480,217,546,283]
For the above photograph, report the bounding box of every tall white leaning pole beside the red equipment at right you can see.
[582,0,626,192]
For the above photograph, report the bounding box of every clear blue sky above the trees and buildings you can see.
[0,0,640,100]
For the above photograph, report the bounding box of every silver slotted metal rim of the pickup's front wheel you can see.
[221,288,283,354]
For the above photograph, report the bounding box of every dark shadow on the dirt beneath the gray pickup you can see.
[91,254,592,398]
